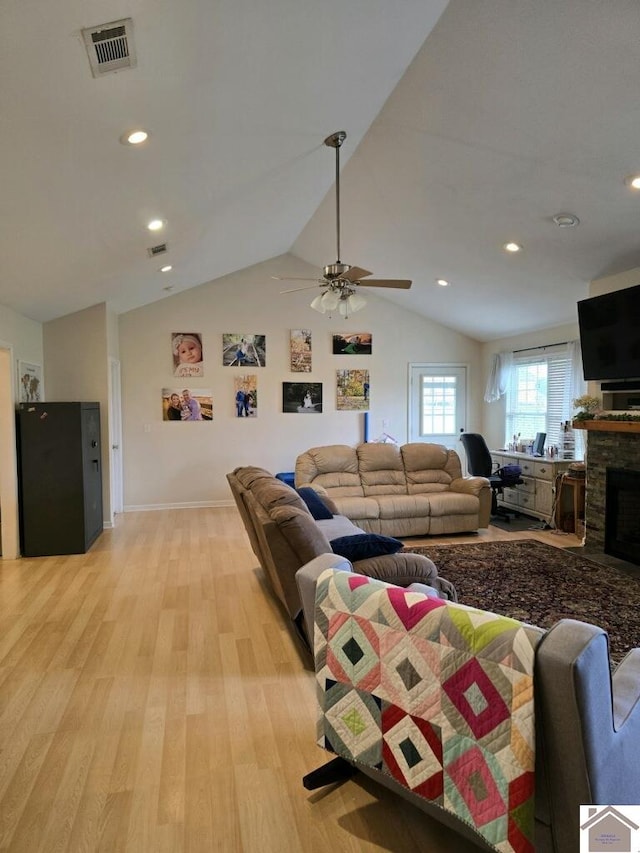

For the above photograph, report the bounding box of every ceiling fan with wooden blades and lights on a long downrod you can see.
[272,130,411,317]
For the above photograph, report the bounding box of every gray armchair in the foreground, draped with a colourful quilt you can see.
[296,554,640,853]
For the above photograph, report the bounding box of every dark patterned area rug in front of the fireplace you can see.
[404,539,640,663]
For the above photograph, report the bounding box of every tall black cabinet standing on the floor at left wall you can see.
[17,403,102,557]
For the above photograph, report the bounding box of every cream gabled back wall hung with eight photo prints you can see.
[119,255,484,509]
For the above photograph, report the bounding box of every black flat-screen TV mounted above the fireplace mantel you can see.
[578,285,640,379]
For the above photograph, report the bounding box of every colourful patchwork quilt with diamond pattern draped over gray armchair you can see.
[314,570,543,853]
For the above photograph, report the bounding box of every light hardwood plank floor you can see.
[0,508,578,853]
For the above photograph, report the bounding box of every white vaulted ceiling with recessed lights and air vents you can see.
[0,0,640,340]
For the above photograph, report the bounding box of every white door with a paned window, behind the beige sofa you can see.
[408,364,467,450]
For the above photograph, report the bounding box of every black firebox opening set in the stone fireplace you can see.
[604,468,640,566]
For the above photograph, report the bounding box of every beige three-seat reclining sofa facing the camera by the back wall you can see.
[295,442,491,537]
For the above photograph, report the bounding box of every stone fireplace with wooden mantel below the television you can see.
[583,421,640,565]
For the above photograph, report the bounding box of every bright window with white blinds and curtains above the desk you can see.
[505,349,573,447]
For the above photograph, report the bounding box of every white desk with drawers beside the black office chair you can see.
[491,450,574,526]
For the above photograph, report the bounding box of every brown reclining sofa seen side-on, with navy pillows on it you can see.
[227,466,456,638]
